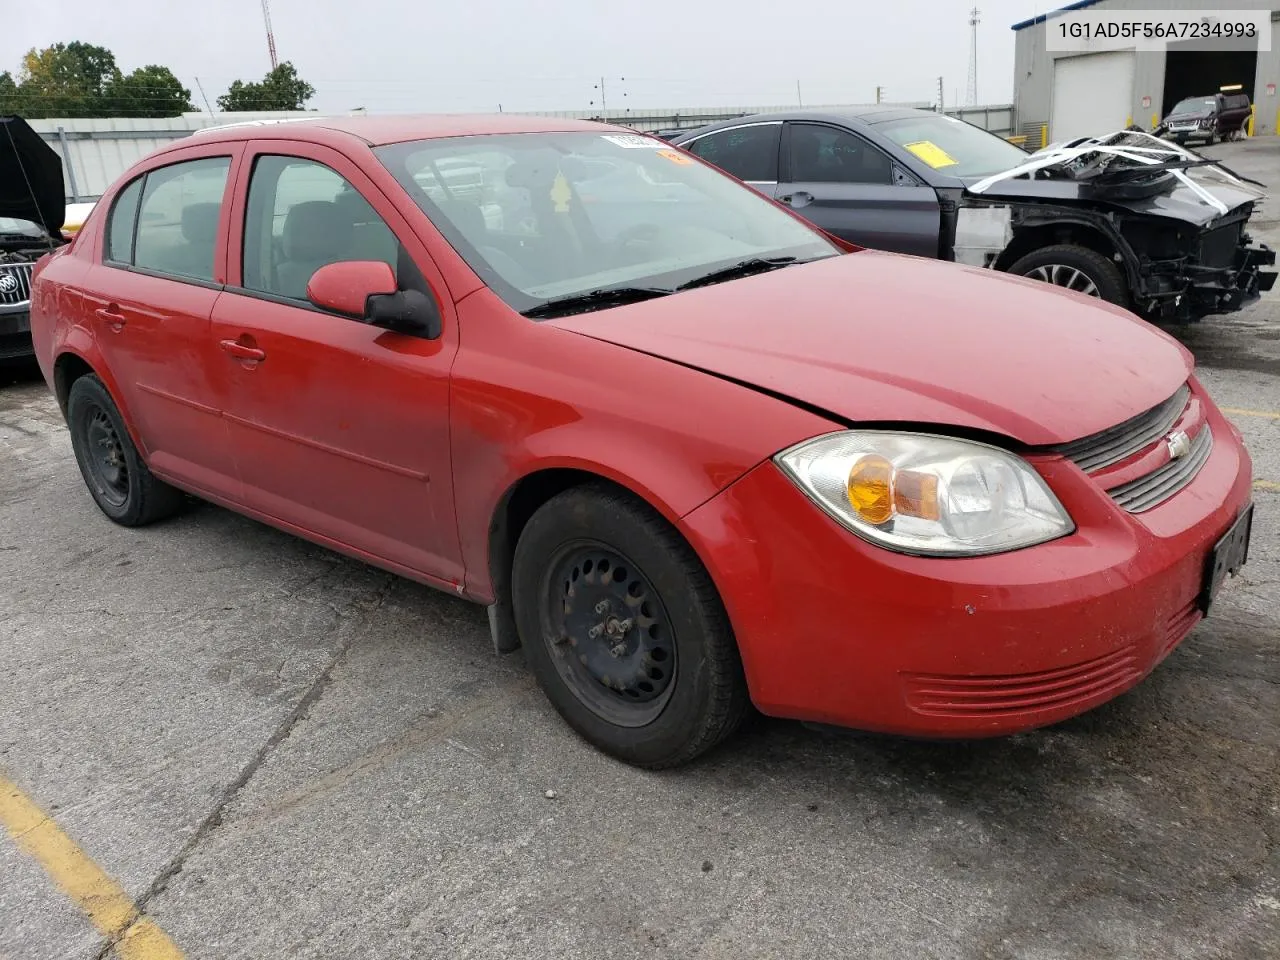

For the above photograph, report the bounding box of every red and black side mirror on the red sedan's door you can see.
[307,260,440,340]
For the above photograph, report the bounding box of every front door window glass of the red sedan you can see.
[243,155,401,300]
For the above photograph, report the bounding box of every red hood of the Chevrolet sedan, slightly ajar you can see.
[547,251,1193,445]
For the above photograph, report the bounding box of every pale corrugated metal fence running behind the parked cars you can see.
[31,102,1014,201]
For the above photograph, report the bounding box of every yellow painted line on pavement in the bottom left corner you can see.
[0,777,183,960]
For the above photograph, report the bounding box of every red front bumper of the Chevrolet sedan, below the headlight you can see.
[684,389,1252,737]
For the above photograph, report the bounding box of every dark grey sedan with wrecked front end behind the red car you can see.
[672,106,1276,321]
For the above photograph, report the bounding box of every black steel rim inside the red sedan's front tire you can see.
[543,541,676,727]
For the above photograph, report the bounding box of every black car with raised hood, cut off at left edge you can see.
[0,116,67,364]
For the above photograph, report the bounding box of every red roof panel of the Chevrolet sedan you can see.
[172,114,636,147]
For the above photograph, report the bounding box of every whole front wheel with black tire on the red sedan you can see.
[512,486,750,769]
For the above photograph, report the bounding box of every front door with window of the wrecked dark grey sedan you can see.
[777,120,941,257]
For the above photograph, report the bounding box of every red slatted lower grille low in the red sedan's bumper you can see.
[904,646,1142,717]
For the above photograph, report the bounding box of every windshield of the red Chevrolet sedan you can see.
[376,133,840,312]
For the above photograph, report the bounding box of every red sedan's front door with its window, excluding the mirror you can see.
[211,142,462,584]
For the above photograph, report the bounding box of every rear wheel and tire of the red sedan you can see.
[67,374,184,526]
